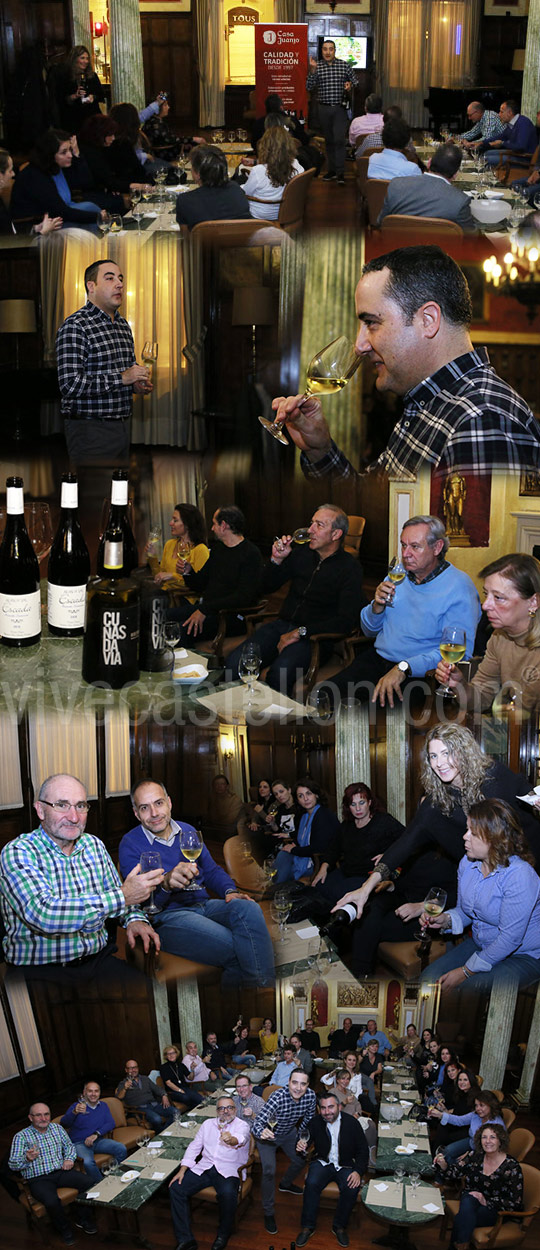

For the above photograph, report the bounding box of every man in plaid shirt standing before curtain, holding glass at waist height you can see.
[56,260,153,464]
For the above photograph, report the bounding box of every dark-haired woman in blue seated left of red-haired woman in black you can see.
[275,778,339,885]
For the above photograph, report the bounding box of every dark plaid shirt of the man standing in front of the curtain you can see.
[56,303,135,421]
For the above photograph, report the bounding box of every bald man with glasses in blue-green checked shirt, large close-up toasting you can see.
[0,774,163,984]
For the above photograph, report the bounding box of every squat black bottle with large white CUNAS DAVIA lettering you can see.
[83,526,140,690]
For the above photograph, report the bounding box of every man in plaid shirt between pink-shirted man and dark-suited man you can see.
[253,1071,316,1233]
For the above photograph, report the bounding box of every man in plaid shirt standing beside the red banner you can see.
[306,39,358,186]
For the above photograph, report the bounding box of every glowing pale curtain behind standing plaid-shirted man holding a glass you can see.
[40,229,205,450]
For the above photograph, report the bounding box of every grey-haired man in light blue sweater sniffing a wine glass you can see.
[318,516,481,708]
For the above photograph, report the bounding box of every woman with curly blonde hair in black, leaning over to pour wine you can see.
[334,724,540,976]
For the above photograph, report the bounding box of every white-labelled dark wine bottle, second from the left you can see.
[48,473,90,638]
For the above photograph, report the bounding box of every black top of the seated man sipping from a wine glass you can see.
[263,546,365,634]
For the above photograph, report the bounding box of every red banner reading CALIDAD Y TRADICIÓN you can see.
[255,21,308,118]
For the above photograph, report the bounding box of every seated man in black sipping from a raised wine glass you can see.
[226,504,364,694]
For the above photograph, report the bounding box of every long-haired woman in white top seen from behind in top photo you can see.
[243,125,304,221]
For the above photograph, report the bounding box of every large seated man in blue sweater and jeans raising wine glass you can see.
[119,778,274,986]
